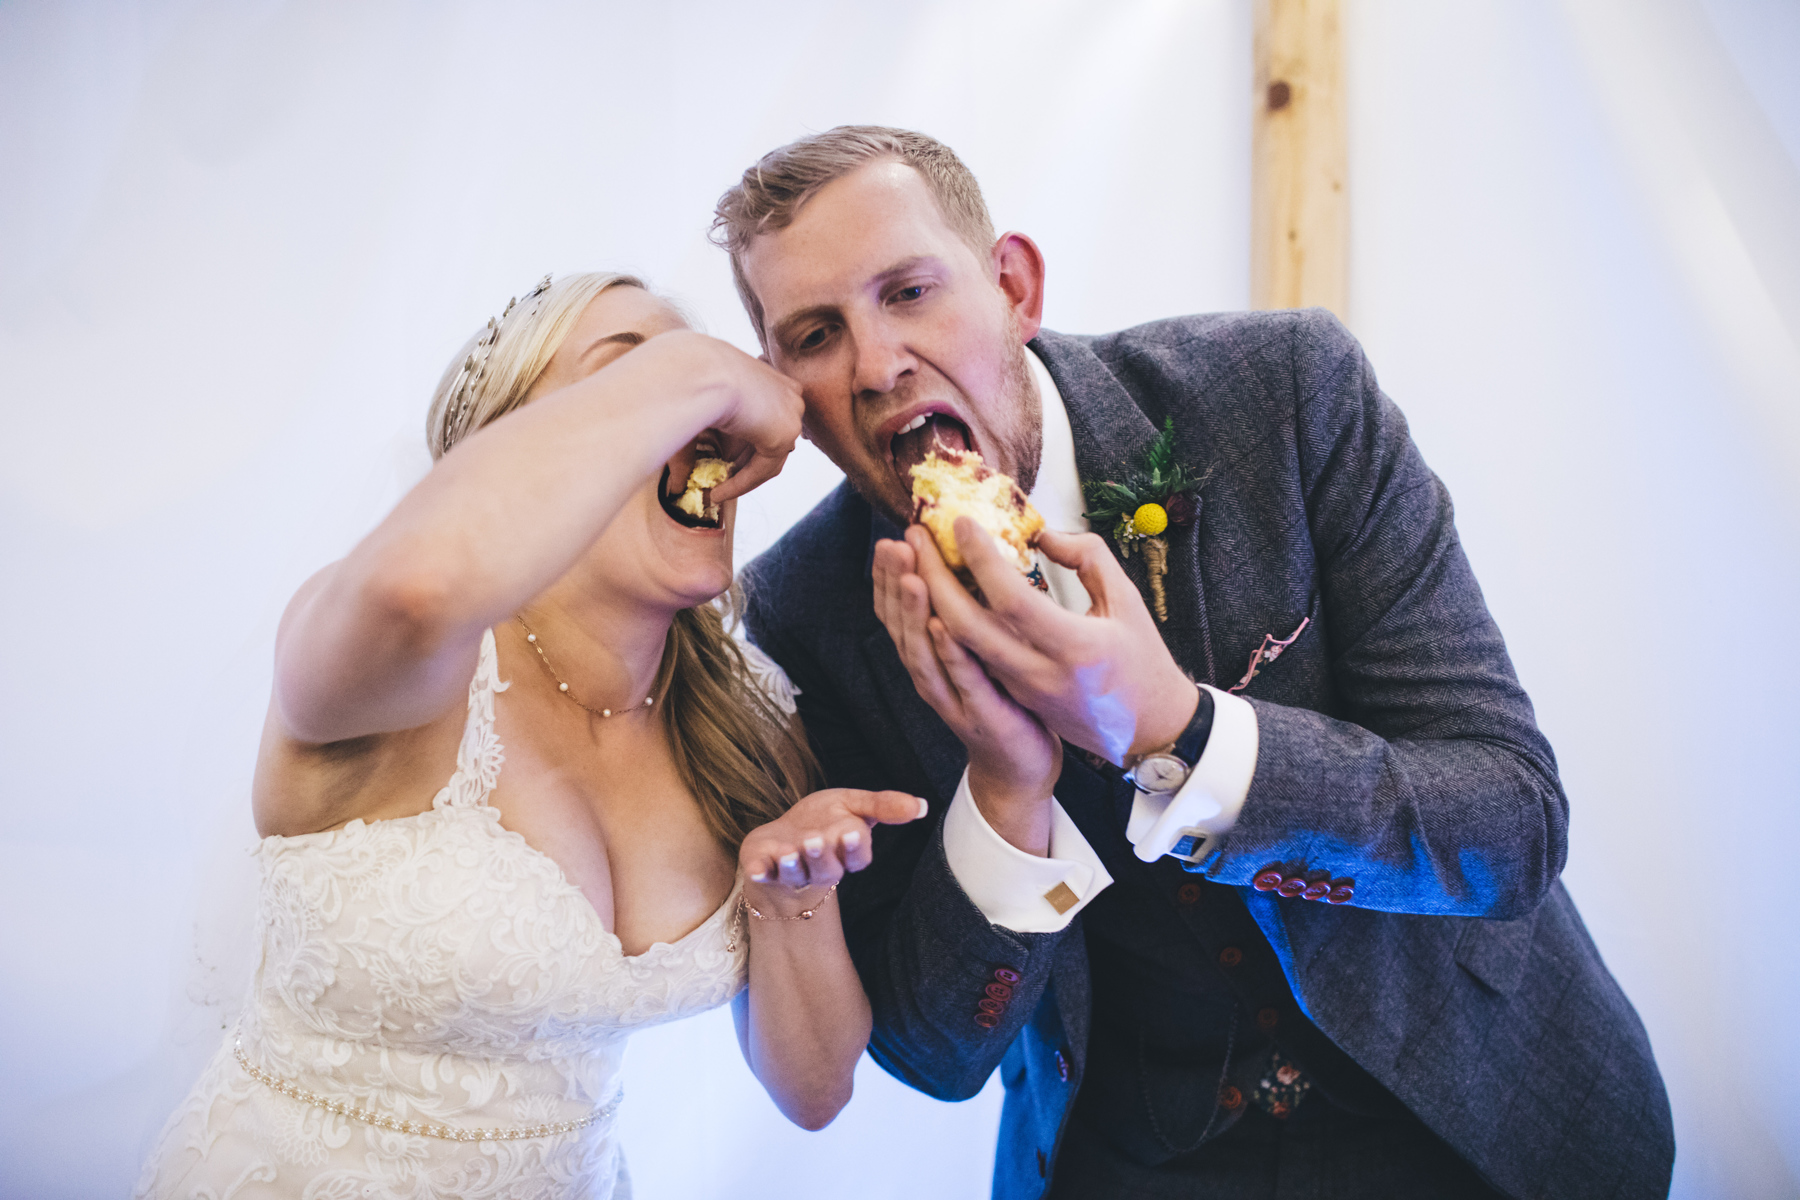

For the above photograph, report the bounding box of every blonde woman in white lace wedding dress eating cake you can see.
[137,273,923,1200]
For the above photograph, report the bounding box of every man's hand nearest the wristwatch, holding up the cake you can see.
[907,518,1199,765]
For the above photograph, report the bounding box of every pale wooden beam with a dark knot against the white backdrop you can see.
[1249,0,1350,318]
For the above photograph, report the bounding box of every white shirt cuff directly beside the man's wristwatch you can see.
[1125,684,1258,862]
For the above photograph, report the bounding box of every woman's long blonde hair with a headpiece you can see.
[425,272,821,851]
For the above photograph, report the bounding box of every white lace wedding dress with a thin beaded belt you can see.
[135,631,792,1200]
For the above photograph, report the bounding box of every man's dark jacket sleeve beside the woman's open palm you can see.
[749,603,1080,1099]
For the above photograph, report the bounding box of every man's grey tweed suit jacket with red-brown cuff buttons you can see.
[747,309,1674,1198]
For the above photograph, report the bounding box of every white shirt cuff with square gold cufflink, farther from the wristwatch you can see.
[943,770,1112,934]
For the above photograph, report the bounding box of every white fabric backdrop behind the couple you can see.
[0,0,1800,1200]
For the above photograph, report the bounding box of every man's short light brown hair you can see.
[711,124,994,338]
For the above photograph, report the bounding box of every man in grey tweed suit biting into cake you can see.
[715,126,1674,1200]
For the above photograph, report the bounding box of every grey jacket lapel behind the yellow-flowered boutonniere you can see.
[1030,331,1219,684]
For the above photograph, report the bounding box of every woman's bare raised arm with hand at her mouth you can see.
[275,329,801,755]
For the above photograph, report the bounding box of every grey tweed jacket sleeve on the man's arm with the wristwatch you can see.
[1206,313,1568,918]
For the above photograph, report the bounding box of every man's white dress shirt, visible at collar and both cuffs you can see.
[943,353,1256,934]
